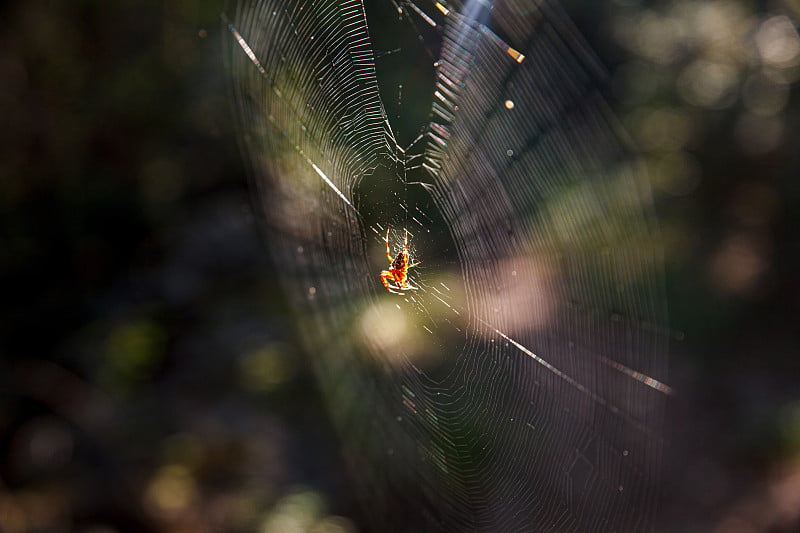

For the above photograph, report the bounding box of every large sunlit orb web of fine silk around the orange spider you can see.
[227,0,672,532]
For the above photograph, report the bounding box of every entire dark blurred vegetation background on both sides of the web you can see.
[0,0,800,533]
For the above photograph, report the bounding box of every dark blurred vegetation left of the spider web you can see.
[0,0,354,533]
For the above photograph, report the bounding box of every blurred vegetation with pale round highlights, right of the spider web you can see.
[593,0,800,532]
